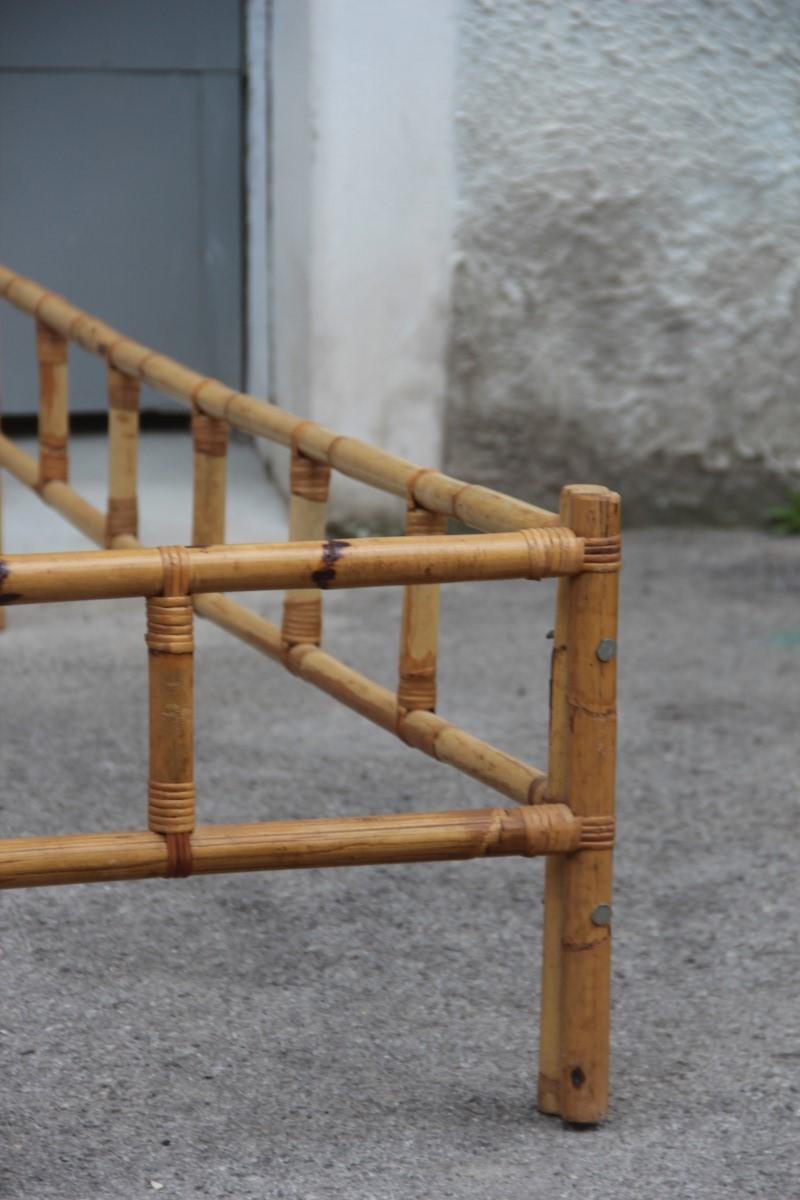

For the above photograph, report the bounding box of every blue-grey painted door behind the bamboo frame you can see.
[0,0,242,413]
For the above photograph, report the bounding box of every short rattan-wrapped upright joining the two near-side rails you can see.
[146,546,194,876]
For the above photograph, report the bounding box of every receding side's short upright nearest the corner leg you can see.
[397,493,447,713]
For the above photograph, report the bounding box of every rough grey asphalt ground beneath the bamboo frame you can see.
[0,438,800,1200]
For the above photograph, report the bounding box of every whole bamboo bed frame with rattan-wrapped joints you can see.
[0,266,620,1124]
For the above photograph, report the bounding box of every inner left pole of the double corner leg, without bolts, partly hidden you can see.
[537,487,571,1116]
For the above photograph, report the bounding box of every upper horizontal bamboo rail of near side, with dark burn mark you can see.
[0,525,584,604]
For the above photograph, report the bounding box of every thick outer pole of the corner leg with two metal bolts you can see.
[555,487,620,1124]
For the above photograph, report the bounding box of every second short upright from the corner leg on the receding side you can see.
[281,432,331,652]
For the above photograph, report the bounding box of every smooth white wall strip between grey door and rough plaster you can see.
[271,0,456,520]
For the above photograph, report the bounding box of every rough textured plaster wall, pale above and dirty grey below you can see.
[447,0,800,521]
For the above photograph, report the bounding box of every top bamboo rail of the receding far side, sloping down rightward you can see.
[0,266,559,533]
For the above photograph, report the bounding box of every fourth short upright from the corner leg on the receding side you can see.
[106,362,139,547]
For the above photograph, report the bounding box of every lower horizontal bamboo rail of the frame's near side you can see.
[0,804,581,888]
